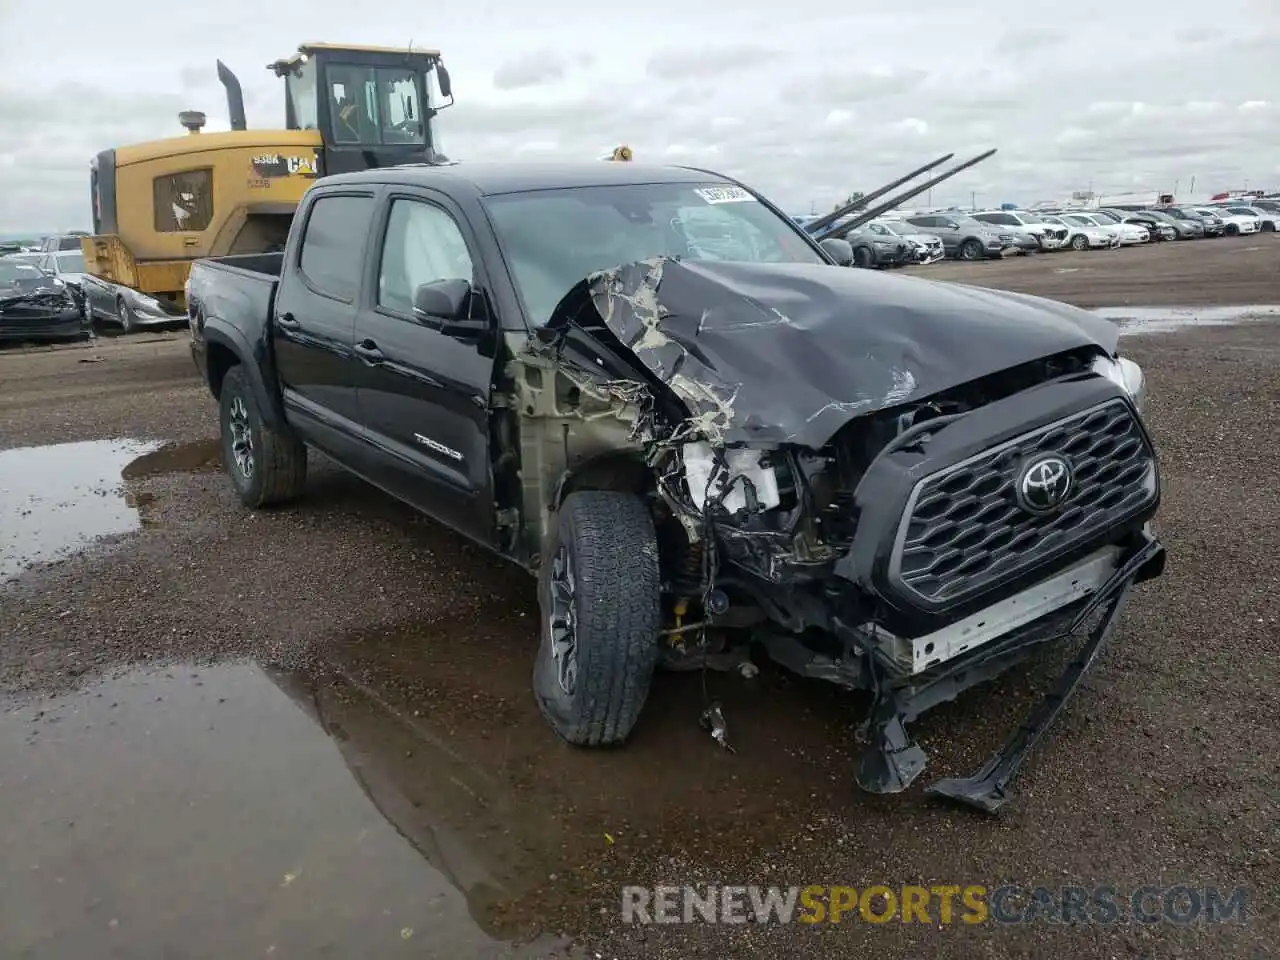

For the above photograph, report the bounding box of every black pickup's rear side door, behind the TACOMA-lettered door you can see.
[271,189,378,460]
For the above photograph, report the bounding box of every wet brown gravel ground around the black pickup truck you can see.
[0,237,1280,960]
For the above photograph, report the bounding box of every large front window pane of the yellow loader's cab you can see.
[326,64,426,145]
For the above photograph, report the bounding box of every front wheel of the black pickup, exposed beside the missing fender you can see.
[534,490,662,746]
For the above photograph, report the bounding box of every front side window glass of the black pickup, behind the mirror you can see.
[378,200,475,315]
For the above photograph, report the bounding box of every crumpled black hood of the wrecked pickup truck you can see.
[552,259,1119,448]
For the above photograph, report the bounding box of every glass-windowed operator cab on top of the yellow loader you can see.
[269,44,453,175]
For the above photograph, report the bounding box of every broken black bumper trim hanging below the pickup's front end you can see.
[858,534,1165,813]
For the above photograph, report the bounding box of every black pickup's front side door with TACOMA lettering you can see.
[356,188,497,543]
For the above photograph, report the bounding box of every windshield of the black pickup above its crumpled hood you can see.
[484,183,827,326]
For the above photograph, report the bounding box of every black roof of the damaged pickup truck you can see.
[320,160,730,196]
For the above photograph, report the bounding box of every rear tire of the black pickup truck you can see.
[218,365,307,508]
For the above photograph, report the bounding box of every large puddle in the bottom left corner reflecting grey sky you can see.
[0,663,576,960]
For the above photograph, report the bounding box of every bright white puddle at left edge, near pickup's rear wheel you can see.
[0,440,156,582]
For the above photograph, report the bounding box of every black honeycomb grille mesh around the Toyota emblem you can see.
[890,399,1157,602]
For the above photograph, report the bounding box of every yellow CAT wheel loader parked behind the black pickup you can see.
[82,44,453,315]
